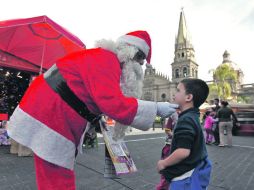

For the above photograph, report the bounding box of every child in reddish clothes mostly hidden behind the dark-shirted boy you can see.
[156,112,178,190]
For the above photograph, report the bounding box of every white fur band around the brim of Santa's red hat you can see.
[117,35,150,56]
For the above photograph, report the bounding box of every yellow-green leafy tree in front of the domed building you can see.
[209,64,237,100]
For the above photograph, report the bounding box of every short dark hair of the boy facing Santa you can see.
[181,79,209,108]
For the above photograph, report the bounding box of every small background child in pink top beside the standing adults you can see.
[204,111,215,144]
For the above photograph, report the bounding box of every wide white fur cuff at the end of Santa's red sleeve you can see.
[131,100,157,131]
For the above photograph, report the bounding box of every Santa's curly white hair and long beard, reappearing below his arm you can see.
[96,40,144,141]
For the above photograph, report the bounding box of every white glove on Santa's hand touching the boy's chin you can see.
[157,102,179,118]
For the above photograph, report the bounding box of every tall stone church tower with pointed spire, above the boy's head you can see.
[171,9,198,83]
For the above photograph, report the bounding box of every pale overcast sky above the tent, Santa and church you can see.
[0,0,254,83]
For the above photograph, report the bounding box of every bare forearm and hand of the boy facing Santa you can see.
[157,148,190,171]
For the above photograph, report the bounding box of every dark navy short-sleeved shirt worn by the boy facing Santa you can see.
[160,108,207,181]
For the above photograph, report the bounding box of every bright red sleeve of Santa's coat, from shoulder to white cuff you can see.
[81,49,138,125]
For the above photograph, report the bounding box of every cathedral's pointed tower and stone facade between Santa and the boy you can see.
[142,10,198,102]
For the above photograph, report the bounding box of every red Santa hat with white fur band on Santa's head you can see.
[117,30,152,64]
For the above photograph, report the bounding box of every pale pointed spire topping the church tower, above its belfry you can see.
[176,8,190,44]
